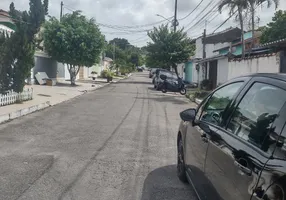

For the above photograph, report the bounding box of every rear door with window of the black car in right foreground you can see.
[205,78,286,200]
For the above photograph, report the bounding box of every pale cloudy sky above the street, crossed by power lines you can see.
[0,0,286,47]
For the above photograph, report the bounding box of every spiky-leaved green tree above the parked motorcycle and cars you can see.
[146,25,195,74]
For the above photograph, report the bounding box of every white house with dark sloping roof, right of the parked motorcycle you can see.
[188,28,241,87]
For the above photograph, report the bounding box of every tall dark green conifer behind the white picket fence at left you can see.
[0,0,48,92]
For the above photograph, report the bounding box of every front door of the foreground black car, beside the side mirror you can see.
[185,81,247,200]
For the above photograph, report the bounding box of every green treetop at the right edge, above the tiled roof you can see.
[260,10,286,43]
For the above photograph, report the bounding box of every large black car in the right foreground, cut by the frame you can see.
[177,74,286,200]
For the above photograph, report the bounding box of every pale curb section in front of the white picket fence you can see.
[0,101,51,124]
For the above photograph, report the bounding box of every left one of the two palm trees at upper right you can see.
[218,0,248,58]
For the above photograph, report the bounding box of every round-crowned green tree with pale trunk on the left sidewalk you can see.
[43,11,105,85]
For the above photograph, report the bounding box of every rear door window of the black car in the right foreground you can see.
[227,82,286,152]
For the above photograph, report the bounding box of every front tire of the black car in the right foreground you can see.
[177,138,188,183]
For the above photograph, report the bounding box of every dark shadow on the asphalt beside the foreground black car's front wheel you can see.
[141,165,197,200]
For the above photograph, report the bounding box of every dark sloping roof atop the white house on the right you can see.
[204,27,241,44]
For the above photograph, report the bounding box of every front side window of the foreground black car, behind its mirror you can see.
[199,82,243,126]
